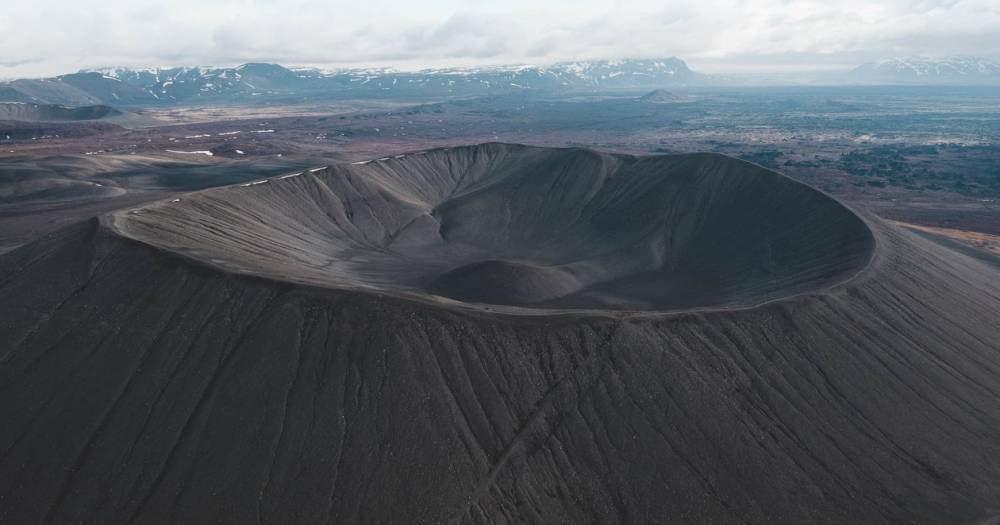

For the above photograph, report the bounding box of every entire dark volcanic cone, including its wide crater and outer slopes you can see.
[0,144,1000,523]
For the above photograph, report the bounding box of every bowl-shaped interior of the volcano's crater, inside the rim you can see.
[114,144,874,310]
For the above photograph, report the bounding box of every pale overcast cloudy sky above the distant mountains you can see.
[0,0,1000,78]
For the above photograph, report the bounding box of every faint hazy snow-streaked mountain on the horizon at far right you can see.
[849,57,1000,85]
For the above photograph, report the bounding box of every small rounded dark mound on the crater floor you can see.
[428,261,582,305]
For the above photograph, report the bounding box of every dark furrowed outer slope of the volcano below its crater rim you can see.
[0,144,1000,523]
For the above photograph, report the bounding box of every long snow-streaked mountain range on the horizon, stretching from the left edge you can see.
[0,57,708,106]
